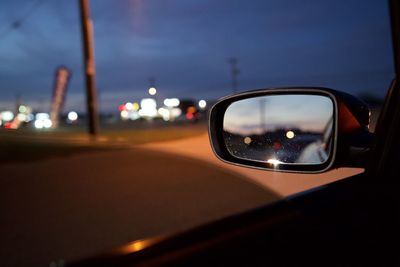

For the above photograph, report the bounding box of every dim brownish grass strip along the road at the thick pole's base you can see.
[0,123,206,165]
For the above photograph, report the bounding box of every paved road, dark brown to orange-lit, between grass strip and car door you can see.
[0,132,359,266]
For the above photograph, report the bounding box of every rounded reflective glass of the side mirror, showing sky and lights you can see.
[223,94,334,165]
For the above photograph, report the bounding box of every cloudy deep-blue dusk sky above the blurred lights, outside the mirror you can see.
[0,0,394,111]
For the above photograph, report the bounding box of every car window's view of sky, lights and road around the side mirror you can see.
[0,0,394,266]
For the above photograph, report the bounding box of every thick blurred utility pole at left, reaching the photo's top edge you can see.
[79,0,99,136]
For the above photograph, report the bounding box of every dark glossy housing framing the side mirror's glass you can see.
[209,87,372,173]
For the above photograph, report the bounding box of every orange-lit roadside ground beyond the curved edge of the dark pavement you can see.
[0,123,363,197]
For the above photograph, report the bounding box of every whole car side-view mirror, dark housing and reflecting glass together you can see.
[209,88,372,173]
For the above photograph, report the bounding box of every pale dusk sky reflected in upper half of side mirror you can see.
[224,95,333,135]
